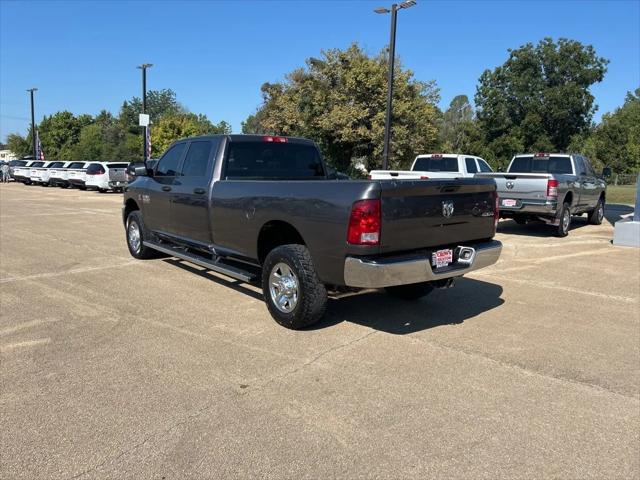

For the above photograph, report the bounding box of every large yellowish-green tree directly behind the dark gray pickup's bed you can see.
[243,44,439,171]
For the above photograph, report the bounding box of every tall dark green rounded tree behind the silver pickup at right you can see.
[475,38,609,159]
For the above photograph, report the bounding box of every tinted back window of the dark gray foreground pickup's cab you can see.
[225,141,325,180]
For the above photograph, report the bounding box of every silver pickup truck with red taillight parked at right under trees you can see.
[477,153,606,237]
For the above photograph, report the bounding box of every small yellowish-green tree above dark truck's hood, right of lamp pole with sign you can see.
[151,113,231,157]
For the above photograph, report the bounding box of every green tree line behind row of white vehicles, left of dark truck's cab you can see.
[6,90,231,161]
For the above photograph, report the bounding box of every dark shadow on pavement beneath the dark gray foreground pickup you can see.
[163,258,504,335]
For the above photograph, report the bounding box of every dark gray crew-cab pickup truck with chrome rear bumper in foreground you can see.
[123,135,502,329]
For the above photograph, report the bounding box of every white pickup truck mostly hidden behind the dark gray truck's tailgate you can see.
[369,153,493,180]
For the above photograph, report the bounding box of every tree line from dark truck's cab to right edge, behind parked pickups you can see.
[242,38,640,173]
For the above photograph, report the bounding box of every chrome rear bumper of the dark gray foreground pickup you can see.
[344,240,502,288]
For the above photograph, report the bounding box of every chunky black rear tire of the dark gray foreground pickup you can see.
[262,245,327,330]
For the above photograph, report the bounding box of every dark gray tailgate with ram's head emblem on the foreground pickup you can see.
[381,179,496,253]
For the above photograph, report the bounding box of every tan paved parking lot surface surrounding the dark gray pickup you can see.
[0,184,640,479]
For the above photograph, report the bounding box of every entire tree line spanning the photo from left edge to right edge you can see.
[6,38,640,174]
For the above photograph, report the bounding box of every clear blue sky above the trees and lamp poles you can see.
[0,0,640,140]
